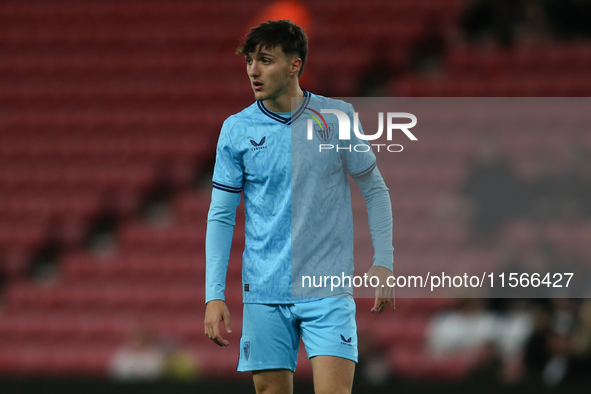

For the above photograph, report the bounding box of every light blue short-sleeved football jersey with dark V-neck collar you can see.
[206,91,376,304]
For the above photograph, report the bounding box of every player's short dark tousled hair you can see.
[236,19,308,77]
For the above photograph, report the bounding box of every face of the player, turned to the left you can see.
[246,46,297,100]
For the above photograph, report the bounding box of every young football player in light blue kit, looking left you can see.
[205,20,394,393]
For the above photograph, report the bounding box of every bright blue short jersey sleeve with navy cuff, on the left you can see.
[213,120,244,193]
